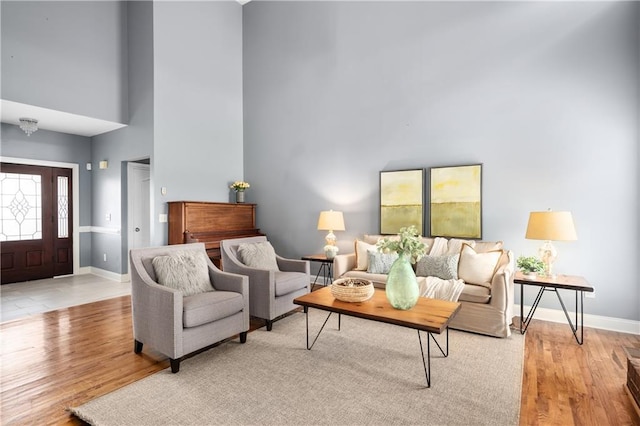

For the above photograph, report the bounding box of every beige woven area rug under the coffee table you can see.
[70,309,524,425]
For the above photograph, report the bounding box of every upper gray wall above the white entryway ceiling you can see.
[1,1,128,123]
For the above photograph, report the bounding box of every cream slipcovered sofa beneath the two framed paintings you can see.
[333,235,515,337]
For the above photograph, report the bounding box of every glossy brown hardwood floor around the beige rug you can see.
[0,296,640,425]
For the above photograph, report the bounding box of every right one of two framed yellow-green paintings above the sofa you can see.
[429,164,482,238]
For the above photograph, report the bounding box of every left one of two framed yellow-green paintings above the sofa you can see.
[380,169,424,235]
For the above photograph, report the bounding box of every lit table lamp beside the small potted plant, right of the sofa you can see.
[525,210,578,277]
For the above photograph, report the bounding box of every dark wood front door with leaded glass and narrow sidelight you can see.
[0,163,73,284]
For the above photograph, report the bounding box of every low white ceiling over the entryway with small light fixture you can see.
[0,99,126,137]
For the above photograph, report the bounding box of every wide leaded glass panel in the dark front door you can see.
[0,173,42,241]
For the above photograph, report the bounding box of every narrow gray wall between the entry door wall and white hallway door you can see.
[92,1,153,273]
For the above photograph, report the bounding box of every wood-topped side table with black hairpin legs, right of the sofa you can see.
[513,271,594,345]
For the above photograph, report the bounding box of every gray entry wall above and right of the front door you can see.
[0,123,97,267]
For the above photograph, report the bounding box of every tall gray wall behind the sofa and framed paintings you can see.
[243,2,640,320]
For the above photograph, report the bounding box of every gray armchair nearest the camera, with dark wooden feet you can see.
[129,243,249,373]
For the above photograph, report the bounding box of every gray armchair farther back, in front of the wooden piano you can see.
[220,236,311,331]
